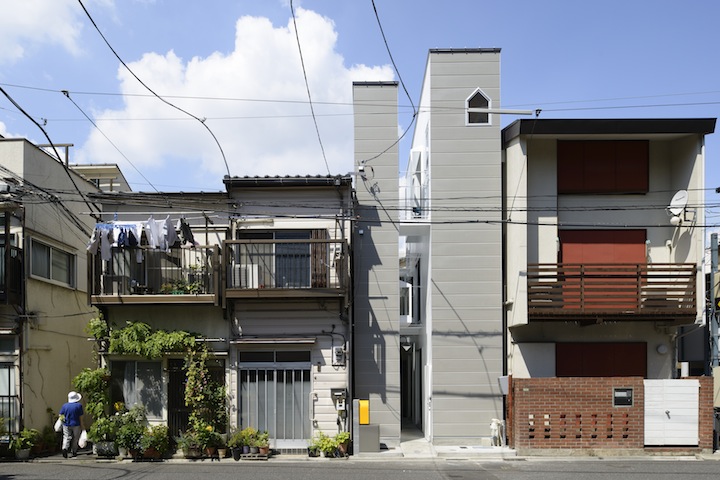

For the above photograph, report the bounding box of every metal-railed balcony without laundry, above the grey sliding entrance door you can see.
[224,239,349,299]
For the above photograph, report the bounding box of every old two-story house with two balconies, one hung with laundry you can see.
[89,176,352,451]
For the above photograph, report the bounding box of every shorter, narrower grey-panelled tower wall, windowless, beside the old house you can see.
[353,84,400,444]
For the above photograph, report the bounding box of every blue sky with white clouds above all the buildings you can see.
[0,0,720,224]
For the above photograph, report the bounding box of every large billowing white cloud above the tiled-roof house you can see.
[76,9,393,190]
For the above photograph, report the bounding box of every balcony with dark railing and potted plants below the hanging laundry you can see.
[88,246,220,305]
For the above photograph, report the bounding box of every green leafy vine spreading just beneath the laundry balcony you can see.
[109,322,195,359]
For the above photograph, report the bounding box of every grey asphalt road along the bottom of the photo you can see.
[0,458,720,480]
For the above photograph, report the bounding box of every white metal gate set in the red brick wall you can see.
[644,379,700,446]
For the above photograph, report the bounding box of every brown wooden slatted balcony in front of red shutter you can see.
[527,263,697,322]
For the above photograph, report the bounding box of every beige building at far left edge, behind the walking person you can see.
[0,138,99,434]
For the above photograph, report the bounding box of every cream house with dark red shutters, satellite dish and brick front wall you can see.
[502,118,715,451]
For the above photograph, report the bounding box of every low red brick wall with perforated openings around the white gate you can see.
[507,377,714,453]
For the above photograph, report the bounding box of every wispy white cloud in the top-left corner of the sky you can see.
[0,0,95,65]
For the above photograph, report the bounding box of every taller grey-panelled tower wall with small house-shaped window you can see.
[430,52,502,439]
